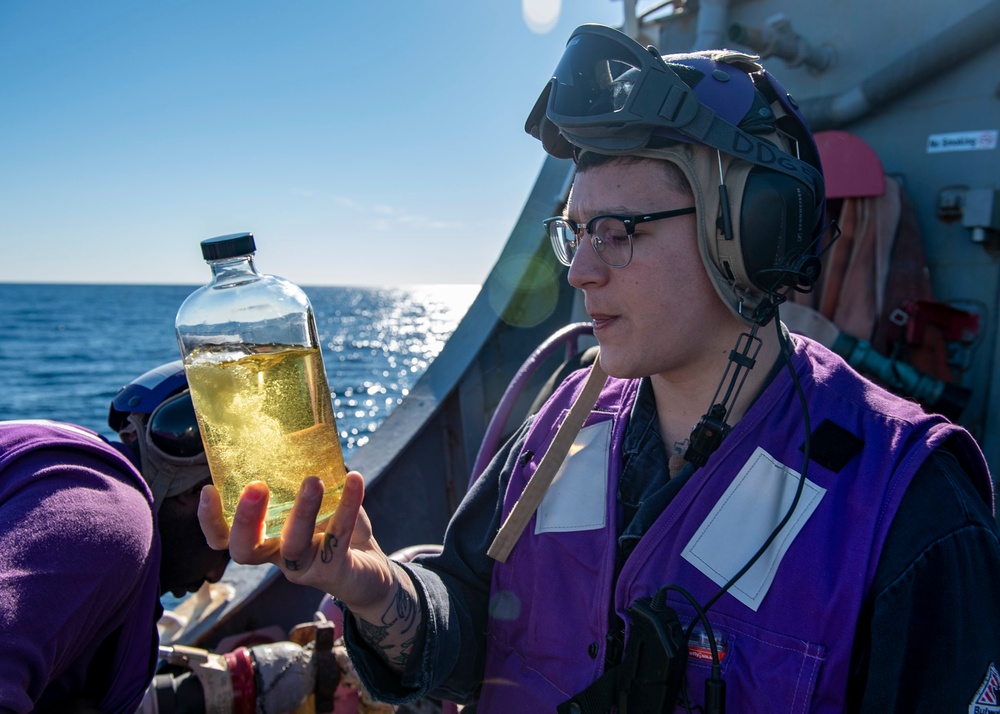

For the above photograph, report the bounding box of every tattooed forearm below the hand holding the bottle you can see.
[351,561,423,672]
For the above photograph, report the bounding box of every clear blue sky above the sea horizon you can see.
[0,0,623,285]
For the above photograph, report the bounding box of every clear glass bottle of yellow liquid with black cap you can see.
[175,233,346,538]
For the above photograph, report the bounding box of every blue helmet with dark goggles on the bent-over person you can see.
[108,360,211,510]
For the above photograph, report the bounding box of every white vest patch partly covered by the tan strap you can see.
[535,419,613,534]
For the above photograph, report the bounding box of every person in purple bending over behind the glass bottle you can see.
[0,361,229,714]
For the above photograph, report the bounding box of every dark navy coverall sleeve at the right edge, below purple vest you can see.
[847,450,1000,714]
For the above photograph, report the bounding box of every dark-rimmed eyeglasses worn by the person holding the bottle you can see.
[542,206,695,268]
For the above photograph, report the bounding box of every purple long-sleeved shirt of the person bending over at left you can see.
[0,449,159,713]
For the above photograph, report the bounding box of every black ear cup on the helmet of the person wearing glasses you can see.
[739,166,823,293]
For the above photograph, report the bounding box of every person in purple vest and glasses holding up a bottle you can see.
[201,25,1000,712]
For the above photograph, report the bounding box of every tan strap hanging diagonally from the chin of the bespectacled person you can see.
[486,355,608,563]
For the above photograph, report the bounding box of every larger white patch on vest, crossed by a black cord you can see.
[681,446,826,612]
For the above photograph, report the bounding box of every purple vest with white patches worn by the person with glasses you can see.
[479,335,993,714]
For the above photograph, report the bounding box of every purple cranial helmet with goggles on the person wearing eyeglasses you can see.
[525,25,825,325]
